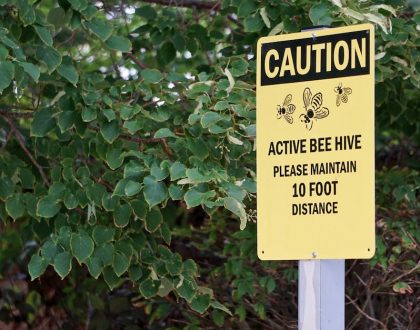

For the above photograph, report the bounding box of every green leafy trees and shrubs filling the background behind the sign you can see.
[0,0,420,329]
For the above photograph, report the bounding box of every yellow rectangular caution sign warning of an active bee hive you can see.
[257,24,375,260]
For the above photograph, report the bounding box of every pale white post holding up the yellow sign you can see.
[298,259,345,330]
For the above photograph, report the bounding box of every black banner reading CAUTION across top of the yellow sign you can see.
[260,30,370,86]
